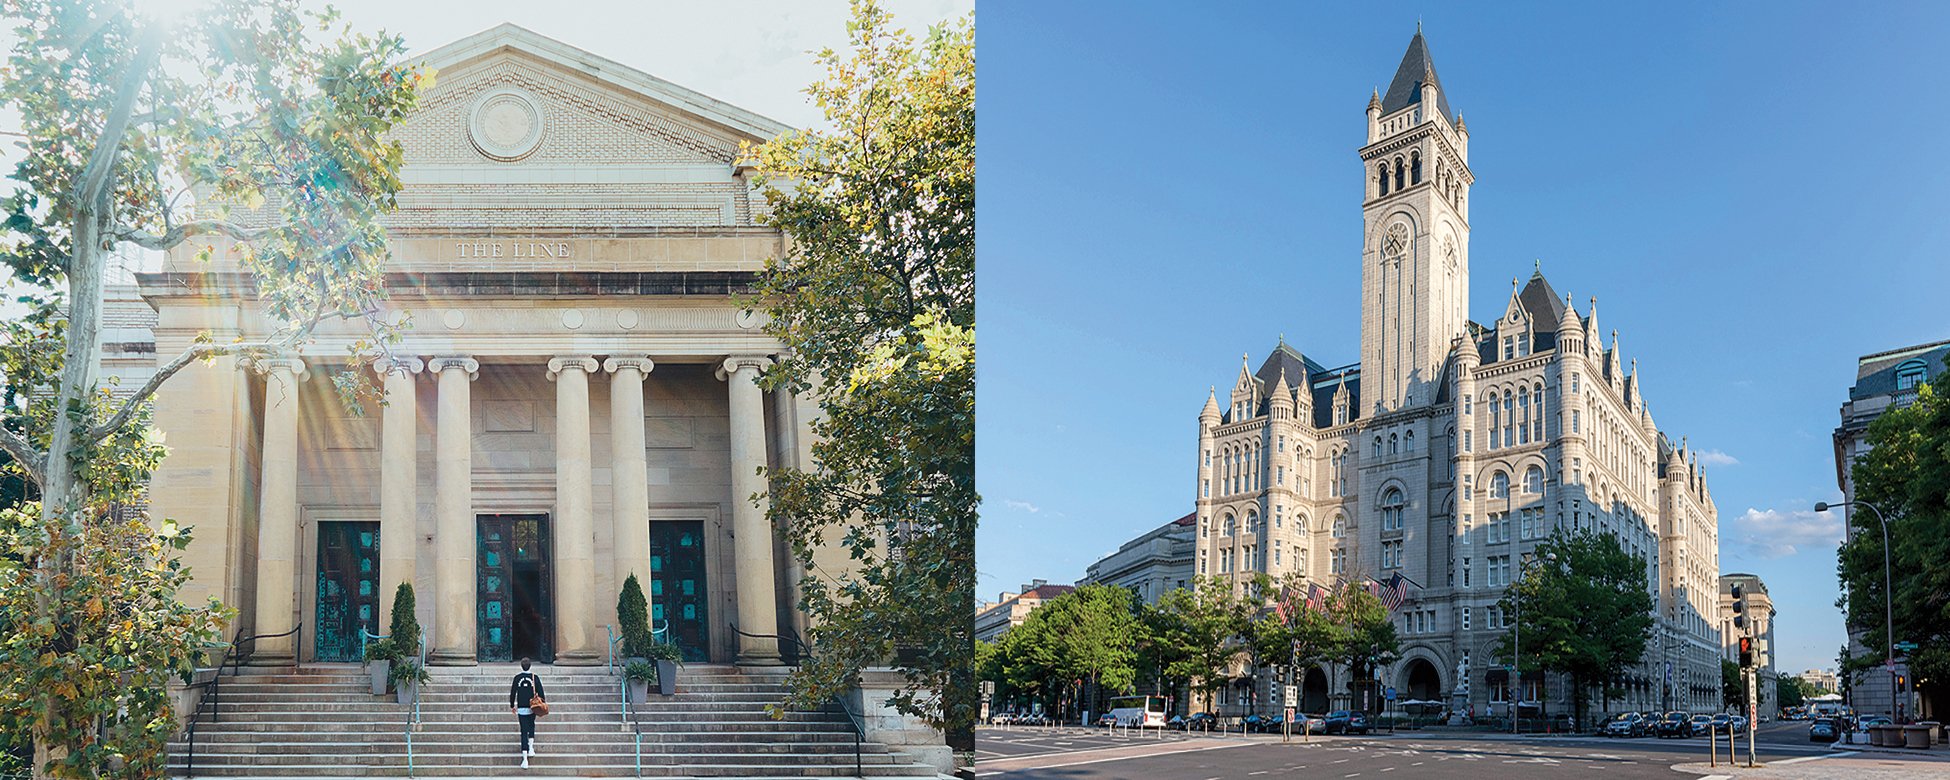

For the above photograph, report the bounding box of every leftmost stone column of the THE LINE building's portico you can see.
[250,357,310,667]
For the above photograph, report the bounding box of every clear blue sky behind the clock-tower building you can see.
[977,2,1950,673]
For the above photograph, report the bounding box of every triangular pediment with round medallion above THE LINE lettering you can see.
[386,23,792,236]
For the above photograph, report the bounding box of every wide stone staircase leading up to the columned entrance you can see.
[170,663,934,778]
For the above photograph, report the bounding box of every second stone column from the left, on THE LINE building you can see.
[367,357,427,644]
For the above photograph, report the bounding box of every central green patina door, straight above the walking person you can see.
[474,515,556,663]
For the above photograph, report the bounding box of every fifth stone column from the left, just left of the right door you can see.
[603,355,657,608]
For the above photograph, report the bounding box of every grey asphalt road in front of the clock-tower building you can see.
[975,723,1887,780]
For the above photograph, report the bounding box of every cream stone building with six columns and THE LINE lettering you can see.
[138,25,844,665]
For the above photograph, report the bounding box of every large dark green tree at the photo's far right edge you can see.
[1835,356,1950,712]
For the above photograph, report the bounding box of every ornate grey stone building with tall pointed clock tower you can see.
[1195,31,1720,716]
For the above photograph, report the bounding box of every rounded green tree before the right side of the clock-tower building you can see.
[1496,530,1654,723]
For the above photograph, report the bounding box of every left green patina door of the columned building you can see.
[312,521,386,661]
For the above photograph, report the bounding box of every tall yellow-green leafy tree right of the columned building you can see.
[739,0,979,749]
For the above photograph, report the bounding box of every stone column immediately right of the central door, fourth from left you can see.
[548,355,606,667]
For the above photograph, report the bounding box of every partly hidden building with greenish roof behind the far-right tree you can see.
[1833,341,1950,718]
